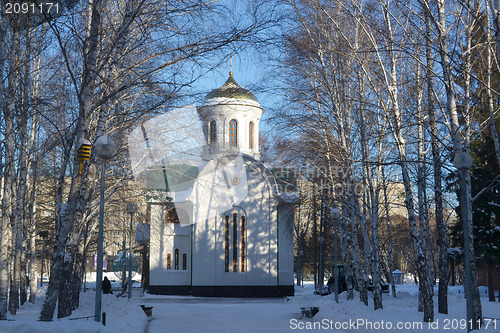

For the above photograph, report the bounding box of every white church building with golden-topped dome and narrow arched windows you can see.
[148,72,296,297]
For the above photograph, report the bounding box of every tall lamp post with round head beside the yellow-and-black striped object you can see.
[94,135,114,322]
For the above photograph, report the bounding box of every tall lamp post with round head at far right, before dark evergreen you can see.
[453,152,475,332]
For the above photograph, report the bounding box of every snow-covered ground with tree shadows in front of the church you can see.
[0,284,500,333]
